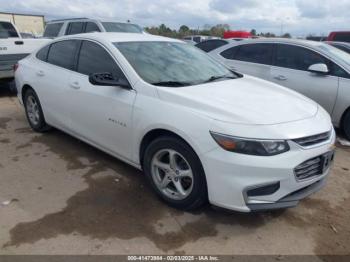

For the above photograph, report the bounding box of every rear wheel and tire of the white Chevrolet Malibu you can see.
[23,89,51,133]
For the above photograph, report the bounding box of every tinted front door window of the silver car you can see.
[275,44,328,71]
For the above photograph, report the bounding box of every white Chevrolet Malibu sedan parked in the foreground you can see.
[15,33,335,212]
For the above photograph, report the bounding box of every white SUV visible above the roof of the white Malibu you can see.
[43,18,145,38]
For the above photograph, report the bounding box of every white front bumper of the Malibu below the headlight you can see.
[201,130,335,212]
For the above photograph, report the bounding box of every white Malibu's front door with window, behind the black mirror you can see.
[68,40,136,158]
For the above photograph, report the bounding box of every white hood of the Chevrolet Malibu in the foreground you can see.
[157,76,318,125]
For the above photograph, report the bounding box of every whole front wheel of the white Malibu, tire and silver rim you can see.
[143,136,208,210]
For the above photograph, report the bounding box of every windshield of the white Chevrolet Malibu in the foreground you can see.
[114,42,237,86]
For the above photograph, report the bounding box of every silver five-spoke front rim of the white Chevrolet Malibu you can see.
[151,149,193,200]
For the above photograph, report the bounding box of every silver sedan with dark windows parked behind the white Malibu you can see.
[209,38,350,139]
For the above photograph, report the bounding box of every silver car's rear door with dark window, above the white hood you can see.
[221,43,273,79]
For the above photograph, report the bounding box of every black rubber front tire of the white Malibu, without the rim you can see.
[143,137,208,210]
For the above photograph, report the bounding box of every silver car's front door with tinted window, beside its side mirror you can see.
[270,44,338,114]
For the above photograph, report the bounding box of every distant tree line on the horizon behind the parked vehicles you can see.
[145,24,291,39]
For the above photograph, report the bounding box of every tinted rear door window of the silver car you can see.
[234,44,273,65]
